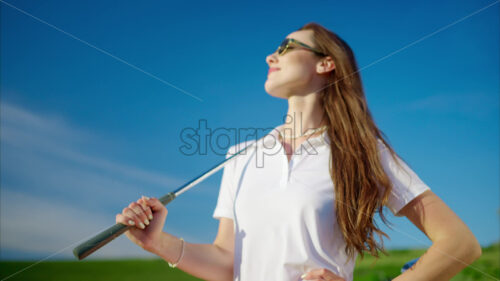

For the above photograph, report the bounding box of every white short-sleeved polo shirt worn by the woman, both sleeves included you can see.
[213,125,429,281]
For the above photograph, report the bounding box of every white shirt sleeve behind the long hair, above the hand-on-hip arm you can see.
[379,142,430,217]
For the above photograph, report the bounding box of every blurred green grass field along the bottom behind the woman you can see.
[0,244,500,281]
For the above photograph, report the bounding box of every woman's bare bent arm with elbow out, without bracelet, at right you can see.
[393,190,481,281]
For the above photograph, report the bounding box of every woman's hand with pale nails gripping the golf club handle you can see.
[116,196,168,251]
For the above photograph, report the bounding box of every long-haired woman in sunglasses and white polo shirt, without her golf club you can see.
[116,23,481,281]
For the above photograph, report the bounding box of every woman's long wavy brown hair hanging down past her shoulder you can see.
[299,23,397,259]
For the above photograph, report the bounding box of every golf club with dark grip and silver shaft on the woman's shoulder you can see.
[73,142,257,260]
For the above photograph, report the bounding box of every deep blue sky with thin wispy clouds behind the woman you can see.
[0,0,500,259]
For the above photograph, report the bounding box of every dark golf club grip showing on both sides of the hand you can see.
[73,192,176,260]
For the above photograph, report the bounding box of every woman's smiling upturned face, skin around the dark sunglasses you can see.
[264,30,324,99]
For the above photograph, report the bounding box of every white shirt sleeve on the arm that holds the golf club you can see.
[213,146,236,219]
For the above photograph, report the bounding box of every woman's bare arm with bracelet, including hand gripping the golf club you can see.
[116,197,234,281]
